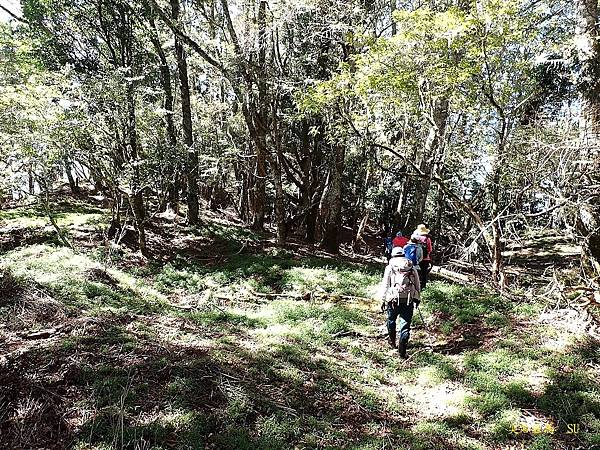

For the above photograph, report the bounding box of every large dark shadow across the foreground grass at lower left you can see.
[0,312,478,449]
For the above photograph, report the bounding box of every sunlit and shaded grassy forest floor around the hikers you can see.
[0,200,600,450]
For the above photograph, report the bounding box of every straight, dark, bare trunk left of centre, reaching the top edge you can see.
[171,0,199,225]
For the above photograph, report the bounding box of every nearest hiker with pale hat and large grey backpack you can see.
[376,247,421,358]
